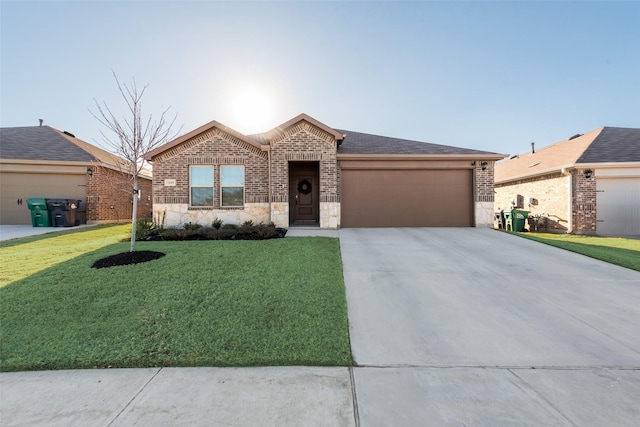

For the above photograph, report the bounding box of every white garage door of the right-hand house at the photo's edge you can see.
[596,178,640,236]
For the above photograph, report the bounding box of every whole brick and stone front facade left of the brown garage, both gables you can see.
[153,121,339,228]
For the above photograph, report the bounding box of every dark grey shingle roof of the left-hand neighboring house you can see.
[0,126,96,162]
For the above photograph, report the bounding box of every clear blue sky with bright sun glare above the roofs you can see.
[0,0,640,154]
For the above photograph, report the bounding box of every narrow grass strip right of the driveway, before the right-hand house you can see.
[514,233,640,271]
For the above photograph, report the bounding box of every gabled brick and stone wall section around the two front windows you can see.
[153,128,270,226]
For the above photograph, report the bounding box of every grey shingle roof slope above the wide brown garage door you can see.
[336,129,495,158]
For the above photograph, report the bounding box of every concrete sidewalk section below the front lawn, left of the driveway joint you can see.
[0,367,356,427]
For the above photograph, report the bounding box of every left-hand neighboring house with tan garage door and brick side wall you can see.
[0,126,151,224]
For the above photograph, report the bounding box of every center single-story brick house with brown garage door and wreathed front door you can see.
[146,114,505,228]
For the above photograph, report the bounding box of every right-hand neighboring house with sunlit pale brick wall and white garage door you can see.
[495,127,640,236]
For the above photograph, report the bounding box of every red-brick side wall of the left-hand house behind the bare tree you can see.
[86,167,152,223]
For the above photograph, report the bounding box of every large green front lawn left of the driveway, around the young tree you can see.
[0,227,353,371]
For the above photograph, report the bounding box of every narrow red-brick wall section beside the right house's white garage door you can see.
[571,169,596,234]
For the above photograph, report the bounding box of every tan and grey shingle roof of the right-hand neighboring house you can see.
[495,127,640,183]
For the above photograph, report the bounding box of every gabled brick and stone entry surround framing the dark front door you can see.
[271,122,340,228]
